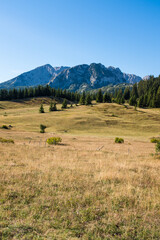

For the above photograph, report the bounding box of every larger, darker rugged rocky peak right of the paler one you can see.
[49,63,141,91]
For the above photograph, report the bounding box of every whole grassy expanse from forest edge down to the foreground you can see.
[0,98,160,240]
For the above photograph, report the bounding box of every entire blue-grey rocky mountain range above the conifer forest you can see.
[0,63,142,92]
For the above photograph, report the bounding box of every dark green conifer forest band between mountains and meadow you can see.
[0,76,160,108]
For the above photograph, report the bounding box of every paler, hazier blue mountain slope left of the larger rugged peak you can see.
[0,64,67,89]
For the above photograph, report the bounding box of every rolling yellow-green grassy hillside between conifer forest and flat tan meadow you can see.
[0,99,160,137]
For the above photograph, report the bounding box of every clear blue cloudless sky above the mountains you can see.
[0,0,160,82]
